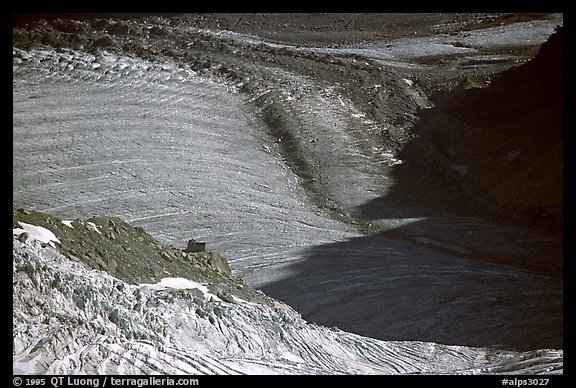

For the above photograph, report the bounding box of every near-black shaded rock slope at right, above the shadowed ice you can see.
[396,28,563,231]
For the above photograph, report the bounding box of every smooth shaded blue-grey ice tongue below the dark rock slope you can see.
[262,227,562,350]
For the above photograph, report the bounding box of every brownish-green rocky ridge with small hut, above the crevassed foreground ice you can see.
[12,208,290,309]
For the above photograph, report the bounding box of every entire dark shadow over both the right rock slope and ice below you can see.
[262,42,563,350]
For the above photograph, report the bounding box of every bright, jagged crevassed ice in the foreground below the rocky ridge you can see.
[12,237,563,375]
